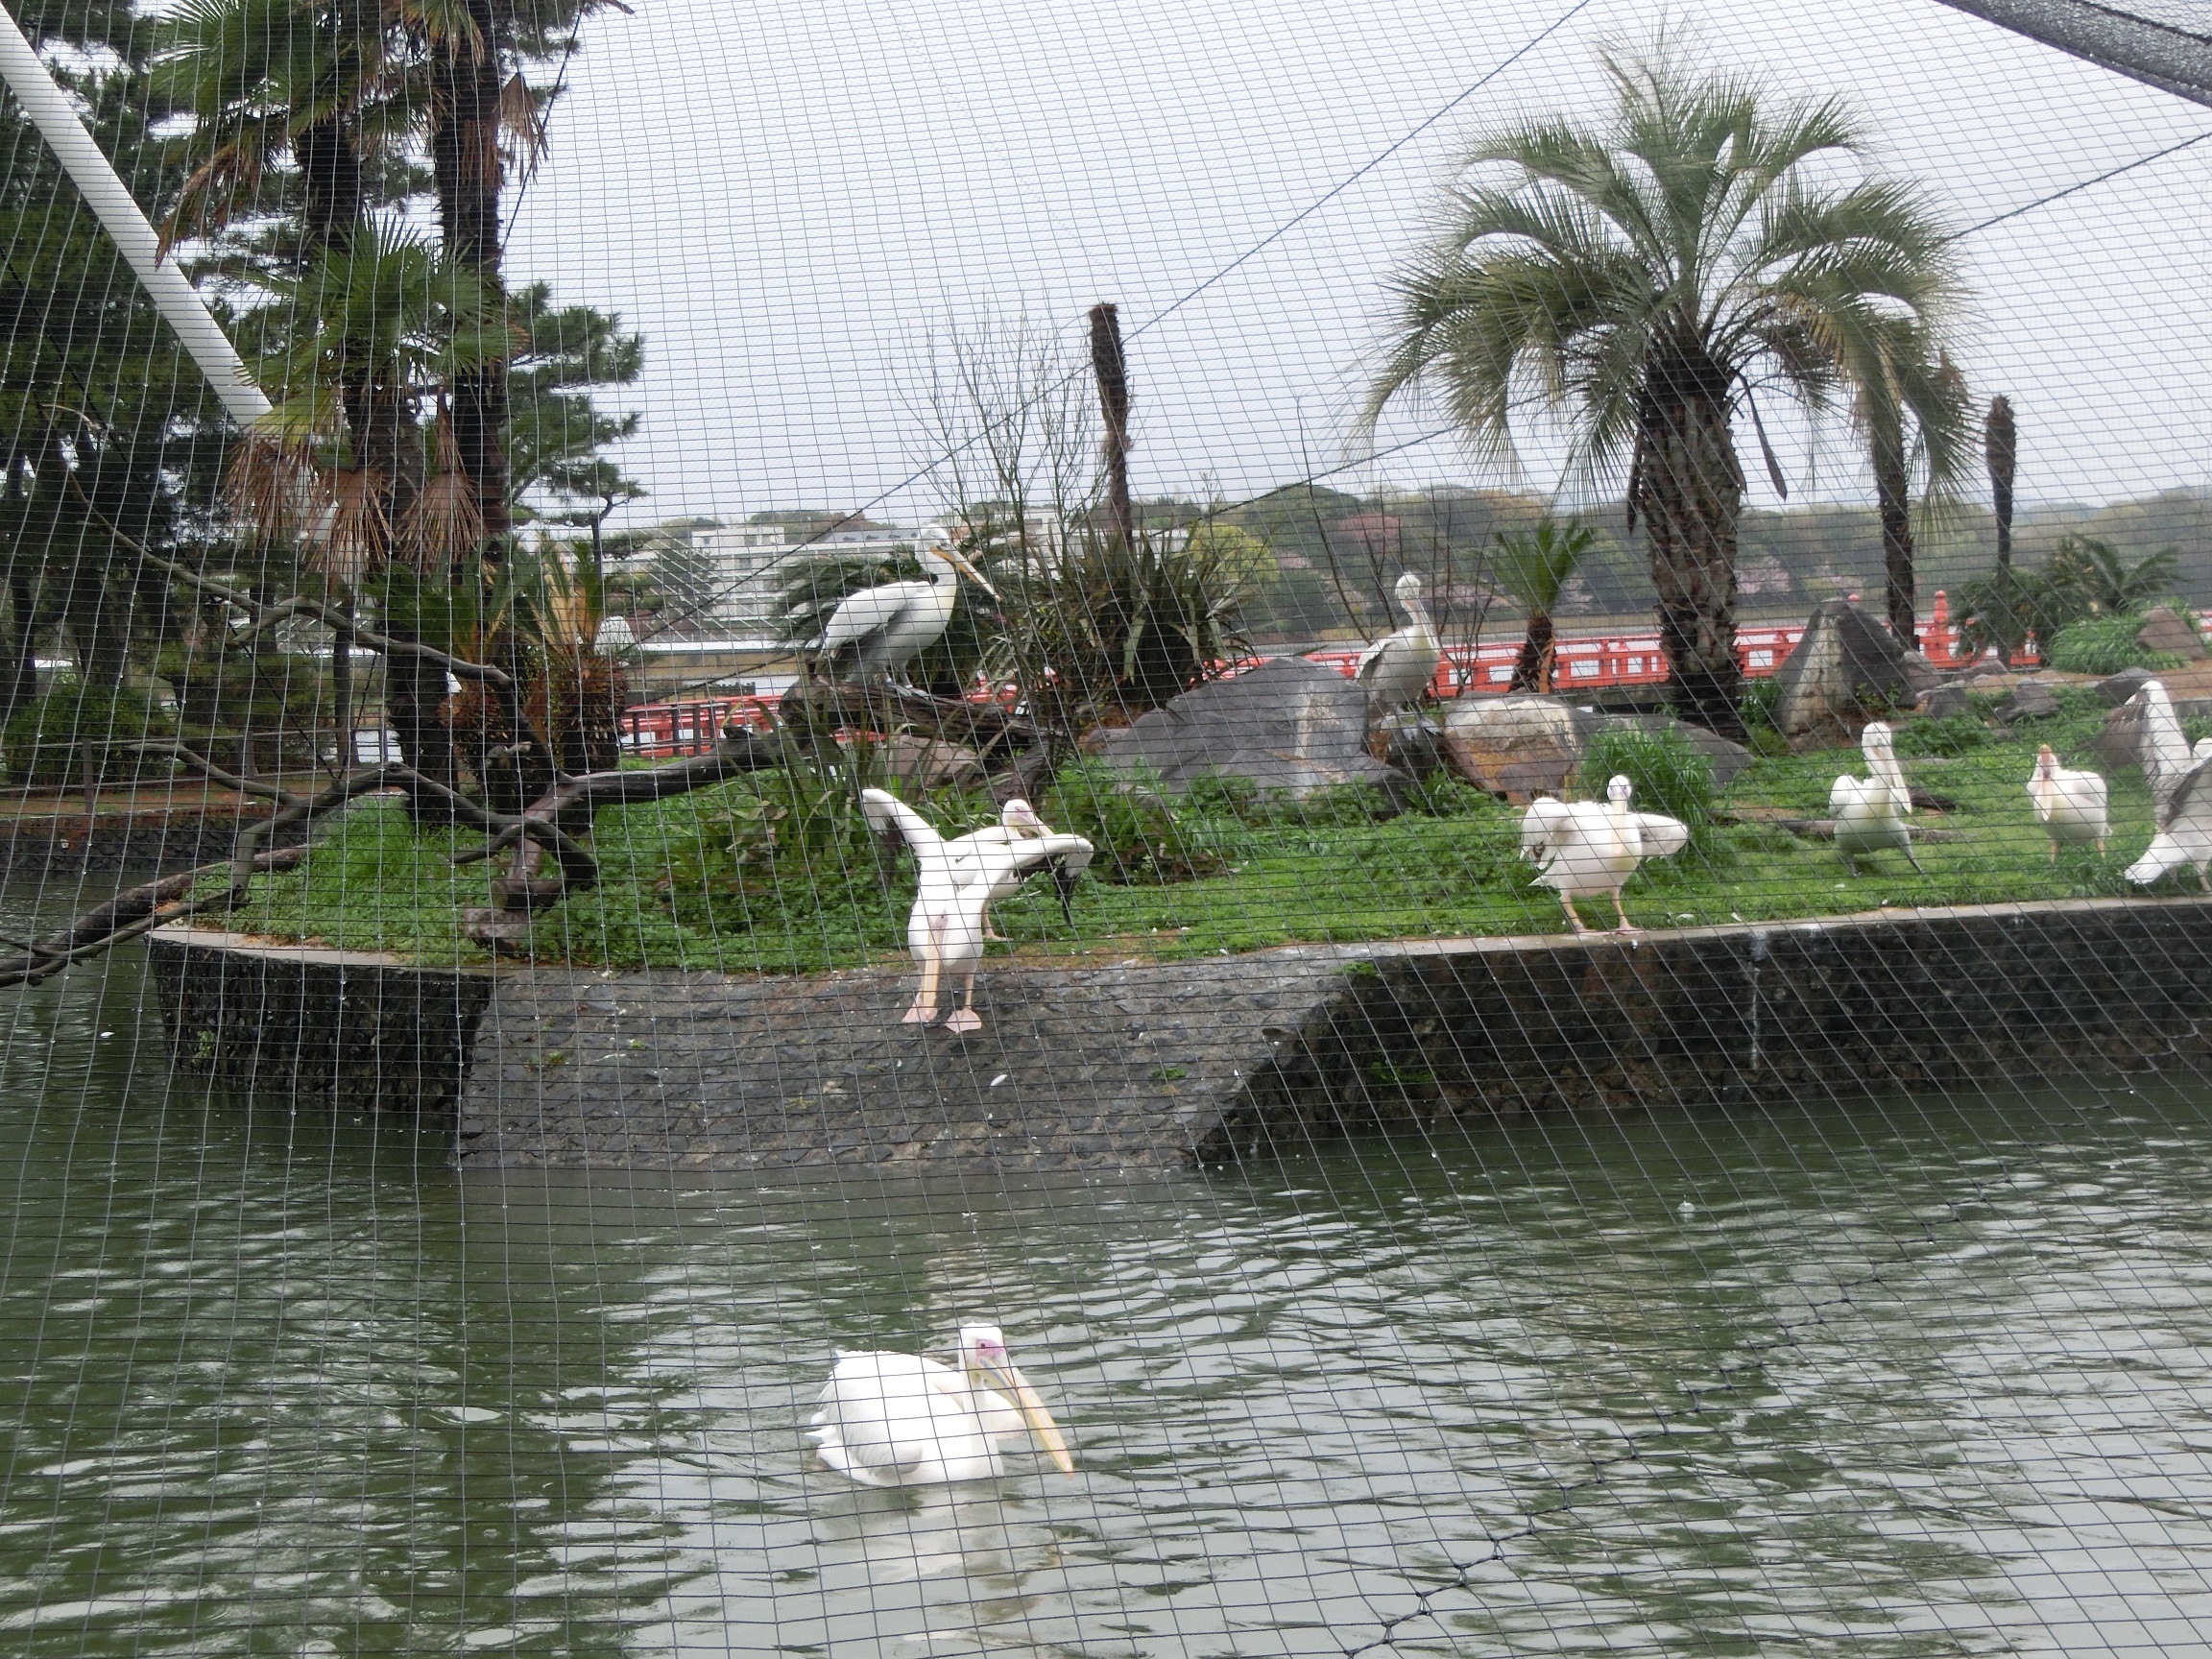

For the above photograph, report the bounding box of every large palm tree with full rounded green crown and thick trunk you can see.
[1365,51,1958,734]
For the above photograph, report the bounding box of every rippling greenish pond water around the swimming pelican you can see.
[0,876,2212,1659]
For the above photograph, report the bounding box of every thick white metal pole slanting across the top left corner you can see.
[0,7,270,427]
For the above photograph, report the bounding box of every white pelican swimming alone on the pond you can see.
[807,1325,1075,1486]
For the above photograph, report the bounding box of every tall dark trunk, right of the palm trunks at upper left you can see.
[429,0,514,546]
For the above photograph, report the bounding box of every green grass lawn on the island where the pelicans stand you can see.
[230,692,2197,974]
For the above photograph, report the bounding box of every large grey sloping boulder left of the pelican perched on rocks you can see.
[1084,657,1403,794]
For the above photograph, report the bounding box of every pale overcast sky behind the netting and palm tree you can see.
[511,0,2212,533]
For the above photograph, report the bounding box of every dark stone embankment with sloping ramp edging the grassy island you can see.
[151,898,2212,1172]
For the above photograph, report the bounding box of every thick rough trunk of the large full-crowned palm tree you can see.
[1628,375,1743,741]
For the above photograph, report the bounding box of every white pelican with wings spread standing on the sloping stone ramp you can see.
[860,790,1091,1033]
